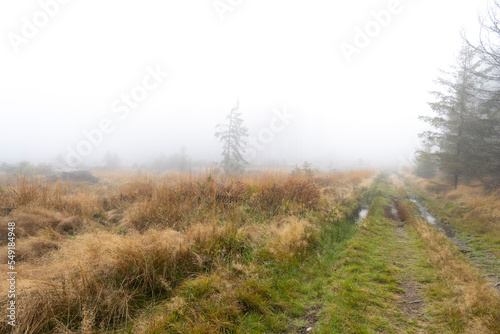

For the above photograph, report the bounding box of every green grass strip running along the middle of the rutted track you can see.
[320,176,429,333]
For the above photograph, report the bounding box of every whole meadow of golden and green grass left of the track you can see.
[0,170,376,333]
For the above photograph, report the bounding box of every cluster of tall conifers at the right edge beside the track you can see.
[416,1,500,189]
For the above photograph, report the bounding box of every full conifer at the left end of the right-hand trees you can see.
[418,45,488,188]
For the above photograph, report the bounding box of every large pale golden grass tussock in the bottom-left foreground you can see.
[2,230,203,332]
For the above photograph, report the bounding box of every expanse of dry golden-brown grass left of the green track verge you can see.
[0,171,374,333]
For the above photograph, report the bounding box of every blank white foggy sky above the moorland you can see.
[0,0,485,164]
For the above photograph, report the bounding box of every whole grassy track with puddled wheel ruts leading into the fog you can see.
[318,176,500,333]
